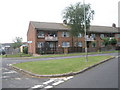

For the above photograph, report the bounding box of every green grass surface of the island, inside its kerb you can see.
[13,56,112,75]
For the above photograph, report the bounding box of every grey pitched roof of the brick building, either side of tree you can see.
[31,21,120,33]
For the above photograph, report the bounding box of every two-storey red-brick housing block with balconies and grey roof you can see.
[27,21,120,54]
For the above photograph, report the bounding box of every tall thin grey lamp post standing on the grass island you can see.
[83,0,88,62]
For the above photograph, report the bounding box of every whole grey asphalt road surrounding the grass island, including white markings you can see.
[1,53,118,89]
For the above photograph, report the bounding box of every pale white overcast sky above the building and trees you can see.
[0,0,120,43]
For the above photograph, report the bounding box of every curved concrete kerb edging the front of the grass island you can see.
[9,57,115,78]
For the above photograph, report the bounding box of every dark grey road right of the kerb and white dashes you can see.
[55,55,118,88]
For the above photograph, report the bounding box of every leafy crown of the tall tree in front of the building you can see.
[63,2,94,36]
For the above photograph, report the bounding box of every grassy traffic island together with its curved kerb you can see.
[9,56,115,78]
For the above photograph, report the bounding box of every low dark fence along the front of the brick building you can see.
[36,47,116,54]
